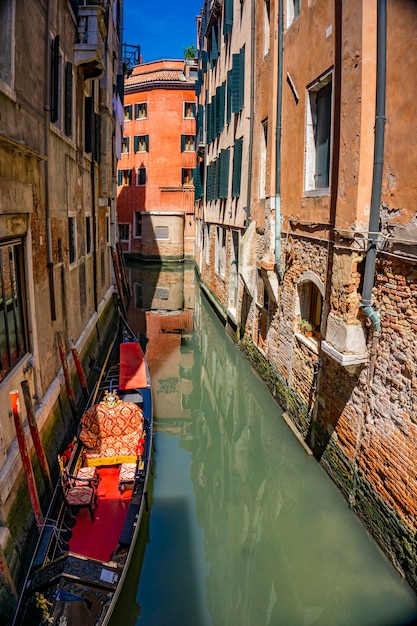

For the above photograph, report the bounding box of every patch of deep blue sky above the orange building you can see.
[123,0,204,63]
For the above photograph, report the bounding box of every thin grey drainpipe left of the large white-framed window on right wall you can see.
[275,0,284,280]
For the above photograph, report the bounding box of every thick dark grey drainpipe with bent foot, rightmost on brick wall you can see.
[360,0,387,332]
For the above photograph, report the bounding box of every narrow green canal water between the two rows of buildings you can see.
[112,265,417,626]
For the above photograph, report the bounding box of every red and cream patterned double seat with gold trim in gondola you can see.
[79,401,143,466]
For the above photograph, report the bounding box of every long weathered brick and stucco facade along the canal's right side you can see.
[196,0,417,589]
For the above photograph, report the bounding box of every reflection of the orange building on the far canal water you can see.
[128,265,195,420]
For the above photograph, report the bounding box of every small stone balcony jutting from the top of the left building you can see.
[74,5,106,79]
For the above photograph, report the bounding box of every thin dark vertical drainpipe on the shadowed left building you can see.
[45,0,56,321]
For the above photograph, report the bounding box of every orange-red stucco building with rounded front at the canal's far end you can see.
[117,60,196,261]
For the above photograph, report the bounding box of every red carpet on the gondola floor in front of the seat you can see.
[69,467,132,561]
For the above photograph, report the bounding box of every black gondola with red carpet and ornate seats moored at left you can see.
[13,316,153,626]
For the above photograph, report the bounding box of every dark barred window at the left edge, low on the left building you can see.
[0,241,27,380]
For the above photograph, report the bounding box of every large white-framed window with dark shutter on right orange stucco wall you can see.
[305,75,332,191]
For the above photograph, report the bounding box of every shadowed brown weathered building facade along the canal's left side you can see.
[0,0,123,623]
